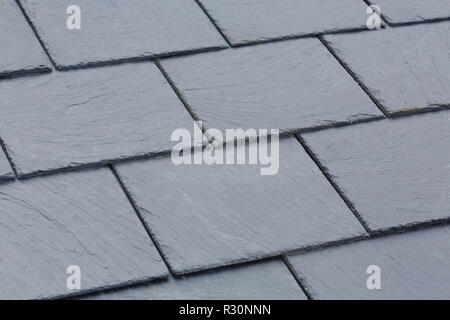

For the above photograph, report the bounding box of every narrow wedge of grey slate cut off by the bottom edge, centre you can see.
[83,260,306,300]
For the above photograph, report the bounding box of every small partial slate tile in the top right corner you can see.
[372,0,450,25]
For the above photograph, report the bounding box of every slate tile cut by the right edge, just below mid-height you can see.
[302,111,450,230]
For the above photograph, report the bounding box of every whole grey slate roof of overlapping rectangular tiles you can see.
[0,0,450,300]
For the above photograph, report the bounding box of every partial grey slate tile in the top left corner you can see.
[0,0,51,77]
